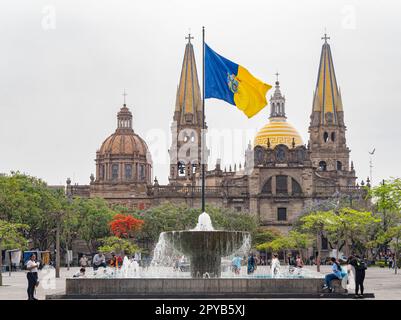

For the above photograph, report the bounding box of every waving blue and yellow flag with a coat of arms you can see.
[205,43,271,118]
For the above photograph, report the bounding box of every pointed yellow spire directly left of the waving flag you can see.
[175,34,202,122]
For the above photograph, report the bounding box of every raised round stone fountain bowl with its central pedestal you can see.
[165,230,250,278]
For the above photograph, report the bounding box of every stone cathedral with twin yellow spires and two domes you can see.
[66,35,362,232]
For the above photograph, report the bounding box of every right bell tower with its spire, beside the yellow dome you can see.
[309,34,356,186]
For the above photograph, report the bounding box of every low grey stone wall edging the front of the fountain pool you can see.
[58,278,346,298]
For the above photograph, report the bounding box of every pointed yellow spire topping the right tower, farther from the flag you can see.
[313,34,343,124]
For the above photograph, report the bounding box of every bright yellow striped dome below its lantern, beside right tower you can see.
[254,117,304,148]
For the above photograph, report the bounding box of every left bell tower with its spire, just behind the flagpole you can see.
[169,34,208,185]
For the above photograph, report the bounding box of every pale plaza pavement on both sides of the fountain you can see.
[0,266,401,300]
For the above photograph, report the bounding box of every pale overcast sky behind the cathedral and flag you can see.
[0,0,401,184]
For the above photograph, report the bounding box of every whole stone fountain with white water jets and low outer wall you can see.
[47,212,346,299]
